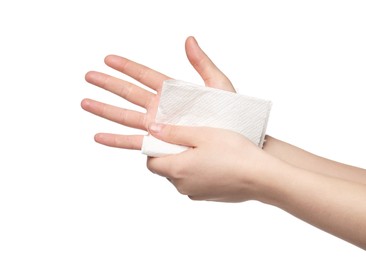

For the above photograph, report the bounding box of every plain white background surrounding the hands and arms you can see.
[0,0,366,260]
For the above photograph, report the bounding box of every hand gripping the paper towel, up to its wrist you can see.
[147,124,280,202]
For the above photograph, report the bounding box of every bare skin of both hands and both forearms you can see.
[81,37,366,249]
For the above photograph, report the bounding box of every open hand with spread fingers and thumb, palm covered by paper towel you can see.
[81,37,235,150]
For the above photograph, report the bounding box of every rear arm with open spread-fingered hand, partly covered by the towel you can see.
[82,37,366,187]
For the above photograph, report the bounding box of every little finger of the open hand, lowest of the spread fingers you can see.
[94,133,143,150]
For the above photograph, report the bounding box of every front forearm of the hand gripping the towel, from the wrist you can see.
[260,160,366,249]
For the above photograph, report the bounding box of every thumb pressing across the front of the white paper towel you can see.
[148,123,207,147]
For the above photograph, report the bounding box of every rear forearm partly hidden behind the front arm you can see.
[263,136,366,184]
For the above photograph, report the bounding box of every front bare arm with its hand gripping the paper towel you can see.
[148,125,366,249]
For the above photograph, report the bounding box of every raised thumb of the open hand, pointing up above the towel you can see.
[185,36,235,92]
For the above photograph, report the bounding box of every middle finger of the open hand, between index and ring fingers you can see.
[85,71,155,108]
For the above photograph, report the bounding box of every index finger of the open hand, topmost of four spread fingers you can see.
[104,55,169,90]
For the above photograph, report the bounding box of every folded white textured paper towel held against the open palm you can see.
[141,80,271,157]
